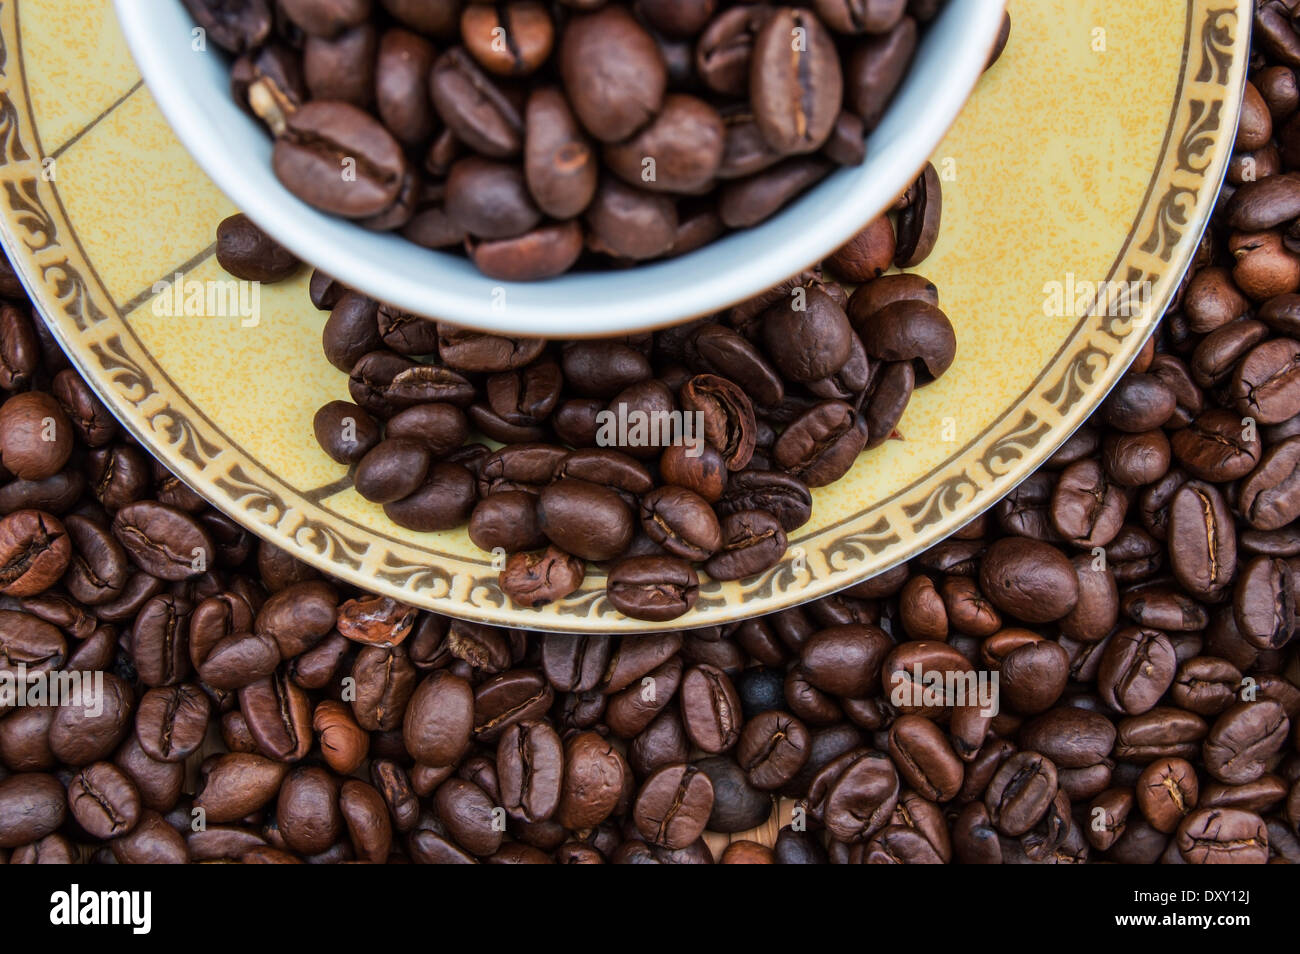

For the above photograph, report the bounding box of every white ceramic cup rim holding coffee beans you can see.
[114,0,1005,338]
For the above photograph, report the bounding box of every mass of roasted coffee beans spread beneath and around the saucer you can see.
[0,162,1300,864]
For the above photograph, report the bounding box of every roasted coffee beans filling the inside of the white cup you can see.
[183,0,945,281]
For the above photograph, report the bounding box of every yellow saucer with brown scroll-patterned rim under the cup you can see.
[0,0,1252,633]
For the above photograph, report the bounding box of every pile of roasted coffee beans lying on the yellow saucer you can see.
[266,166,957,621]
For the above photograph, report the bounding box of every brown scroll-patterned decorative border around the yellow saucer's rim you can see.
[0,0,1251,633]
